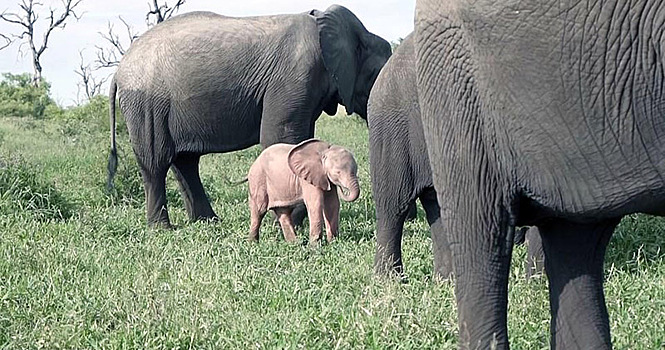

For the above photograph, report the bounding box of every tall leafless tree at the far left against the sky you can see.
[0,0,83,86]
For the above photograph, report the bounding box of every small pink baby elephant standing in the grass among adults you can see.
[247,139,360,244]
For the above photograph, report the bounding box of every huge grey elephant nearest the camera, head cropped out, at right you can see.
[415,0,665,349]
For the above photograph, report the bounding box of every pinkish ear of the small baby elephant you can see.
[288,139,331,191]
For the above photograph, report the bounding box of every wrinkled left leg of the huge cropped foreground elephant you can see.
[434,174,514,349]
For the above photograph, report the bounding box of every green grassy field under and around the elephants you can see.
[0,110,665,349]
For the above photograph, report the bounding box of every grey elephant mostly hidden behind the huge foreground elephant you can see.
[367,34,543,278]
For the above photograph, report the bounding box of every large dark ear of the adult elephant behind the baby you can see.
[316,5,365,114]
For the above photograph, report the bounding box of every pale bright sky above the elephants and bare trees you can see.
[0,0,415,106]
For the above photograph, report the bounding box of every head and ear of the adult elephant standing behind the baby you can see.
[311,5,392,118]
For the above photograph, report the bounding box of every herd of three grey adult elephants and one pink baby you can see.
[104,0,665,349]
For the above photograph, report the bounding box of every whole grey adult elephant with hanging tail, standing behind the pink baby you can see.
[109,5,391,226]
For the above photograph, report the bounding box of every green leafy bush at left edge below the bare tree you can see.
[0,73,60,119]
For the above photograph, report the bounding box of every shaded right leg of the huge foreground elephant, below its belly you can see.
[538,219,619,349]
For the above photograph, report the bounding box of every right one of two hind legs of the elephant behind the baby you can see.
[172,154,217,221]
